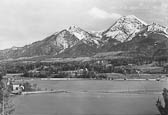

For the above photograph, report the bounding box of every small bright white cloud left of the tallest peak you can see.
[88,7,121,19]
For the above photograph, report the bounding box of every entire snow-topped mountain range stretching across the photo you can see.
[0,15,168,59]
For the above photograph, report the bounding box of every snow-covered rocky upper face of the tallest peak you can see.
[103,15,147,42]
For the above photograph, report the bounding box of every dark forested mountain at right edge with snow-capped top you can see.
[106,24,168,57]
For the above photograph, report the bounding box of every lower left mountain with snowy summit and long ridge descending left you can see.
[0,26,101,59]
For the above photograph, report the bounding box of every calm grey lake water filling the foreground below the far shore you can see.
[14,80,168,115]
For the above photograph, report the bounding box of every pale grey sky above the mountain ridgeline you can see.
[0,0,168,50]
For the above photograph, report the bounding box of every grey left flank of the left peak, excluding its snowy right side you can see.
[0,30,79,59]
